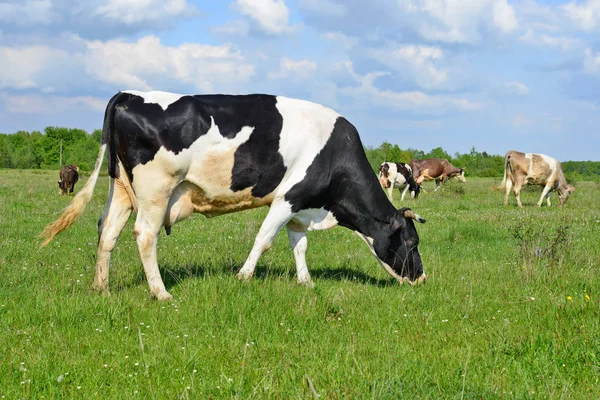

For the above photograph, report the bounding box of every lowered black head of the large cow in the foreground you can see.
[374,208,426,283]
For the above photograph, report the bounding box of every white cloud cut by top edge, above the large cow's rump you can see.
[95,0,196,24]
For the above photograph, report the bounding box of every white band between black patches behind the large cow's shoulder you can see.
[277,96,340,194]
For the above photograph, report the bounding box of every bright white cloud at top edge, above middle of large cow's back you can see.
[231,0,292,36]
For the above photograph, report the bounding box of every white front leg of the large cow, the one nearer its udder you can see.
[237,201,294,280]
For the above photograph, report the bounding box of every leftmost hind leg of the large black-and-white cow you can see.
[92,178,132,294]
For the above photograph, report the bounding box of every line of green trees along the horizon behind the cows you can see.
[0,126,600,181]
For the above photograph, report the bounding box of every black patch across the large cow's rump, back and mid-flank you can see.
[114,94,286,197]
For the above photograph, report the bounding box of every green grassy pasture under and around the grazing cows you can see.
[0,170,600,399]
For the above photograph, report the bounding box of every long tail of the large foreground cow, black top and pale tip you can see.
[40,92,130,247]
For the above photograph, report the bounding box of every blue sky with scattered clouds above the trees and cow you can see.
[0,0,600,161]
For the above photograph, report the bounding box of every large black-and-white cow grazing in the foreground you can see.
[41,91,426,299]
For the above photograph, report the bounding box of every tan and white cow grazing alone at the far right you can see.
[498,150,575,207]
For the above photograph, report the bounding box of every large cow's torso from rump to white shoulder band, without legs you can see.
[115,92,342,215]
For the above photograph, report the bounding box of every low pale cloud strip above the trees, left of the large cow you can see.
[0,93,106,115]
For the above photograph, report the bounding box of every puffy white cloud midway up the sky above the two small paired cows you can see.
[367,45,448,88]
